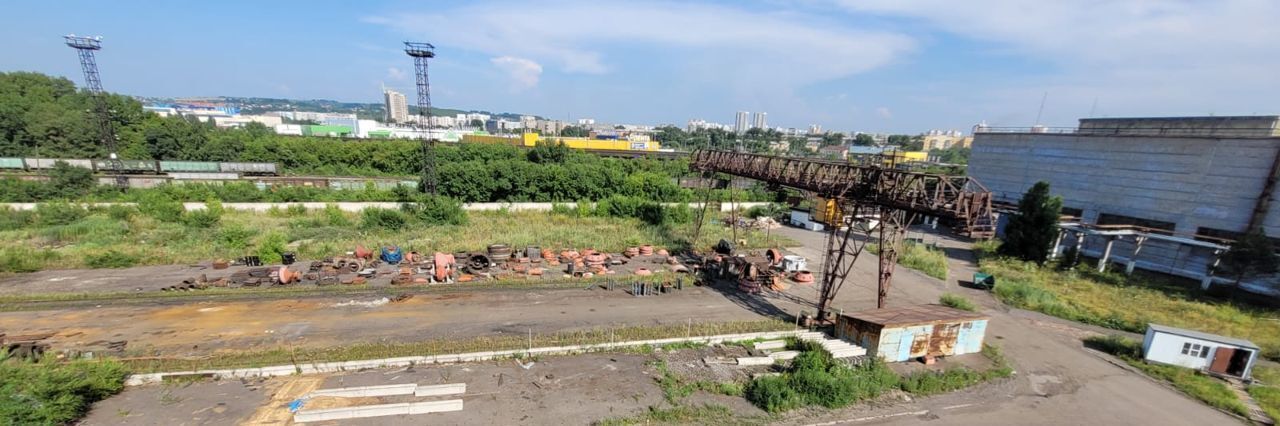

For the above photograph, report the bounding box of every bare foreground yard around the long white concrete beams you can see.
[83,347,1009,426]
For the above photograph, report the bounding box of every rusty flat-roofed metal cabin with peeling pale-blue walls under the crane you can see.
[836,304,988,362]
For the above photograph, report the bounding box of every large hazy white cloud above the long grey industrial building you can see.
[836,0,1280,124]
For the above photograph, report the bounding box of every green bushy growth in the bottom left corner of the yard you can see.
[0,356,128,425]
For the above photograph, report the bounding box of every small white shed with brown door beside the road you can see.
[1142,324,1261,380]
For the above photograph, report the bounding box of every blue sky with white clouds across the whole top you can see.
[0,0,1280,133]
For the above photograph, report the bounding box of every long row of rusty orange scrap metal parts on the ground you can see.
[163,244,698,292]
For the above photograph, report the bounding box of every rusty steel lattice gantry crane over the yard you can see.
[689,150,995,321]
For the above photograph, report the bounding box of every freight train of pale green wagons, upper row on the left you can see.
[0,157,279,177]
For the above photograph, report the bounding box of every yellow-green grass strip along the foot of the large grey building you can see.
[982,258,1280,359]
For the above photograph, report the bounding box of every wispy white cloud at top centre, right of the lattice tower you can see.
[365,0,914,88]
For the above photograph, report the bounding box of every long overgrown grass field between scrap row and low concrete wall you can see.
[0,202,788,272]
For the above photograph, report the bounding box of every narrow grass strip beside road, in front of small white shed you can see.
[1084,335,1248,416]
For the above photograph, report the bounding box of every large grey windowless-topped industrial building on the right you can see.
[969,115,1280,296]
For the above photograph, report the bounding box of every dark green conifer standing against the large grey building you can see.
[1000,180,1062,265]
